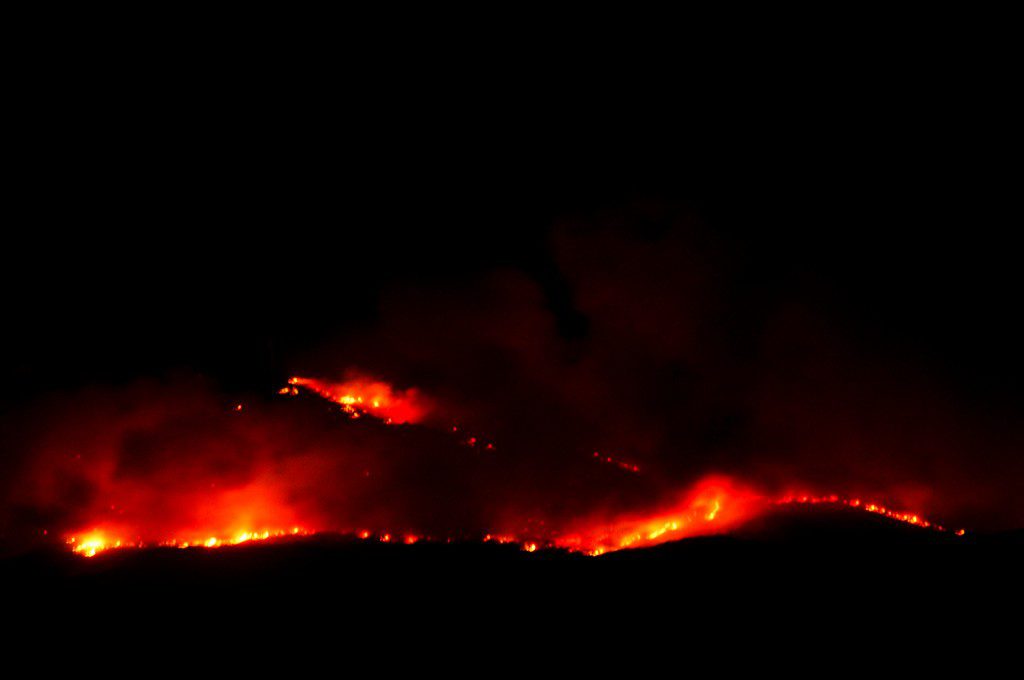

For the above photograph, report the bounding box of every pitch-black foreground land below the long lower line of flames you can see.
[0,508,1024,656]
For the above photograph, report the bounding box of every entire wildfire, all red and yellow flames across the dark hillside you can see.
[54,377,965,557]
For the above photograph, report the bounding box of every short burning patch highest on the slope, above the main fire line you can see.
[280,377,430,425]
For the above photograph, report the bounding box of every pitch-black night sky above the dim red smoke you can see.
[3,55,1024,398]
